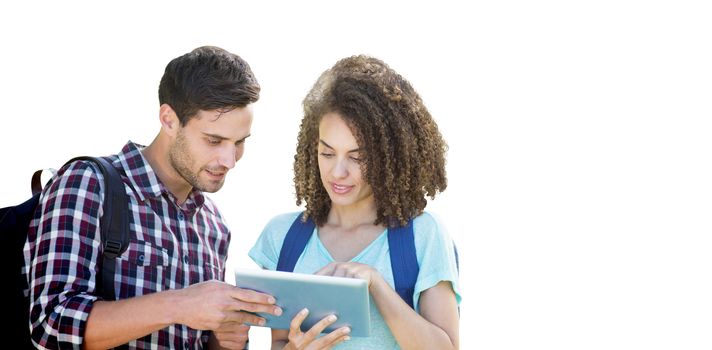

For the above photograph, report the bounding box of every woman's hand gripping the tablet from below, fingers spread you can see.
[284,309,351,350]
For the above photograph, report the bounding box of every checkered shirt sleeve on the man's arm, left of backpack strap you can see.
[26,161,103,349]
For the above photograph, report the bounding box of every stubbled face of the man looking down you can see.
[168,105,252,193]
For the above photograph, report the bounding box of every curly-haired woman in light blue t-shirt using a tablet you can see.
[250,56,460,349]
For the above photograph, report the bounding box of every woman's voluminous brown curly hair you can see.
[294,55,447,227]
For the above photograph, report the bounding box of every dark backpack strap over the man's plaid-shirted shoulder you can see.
[67,157,129,300]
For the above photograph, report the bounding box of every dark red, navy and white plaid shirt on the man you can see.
[24,142,230,349]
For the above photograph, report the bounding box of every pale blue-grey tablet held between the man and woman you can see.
[235,269,371,337]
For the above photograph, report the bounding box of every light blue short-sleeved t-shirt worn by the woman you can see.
[249,212,460,349]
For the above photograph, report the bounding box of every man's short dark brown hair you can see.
[158,46,260,125]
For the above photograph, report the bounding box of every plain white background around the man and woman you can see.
[0,1,712,349]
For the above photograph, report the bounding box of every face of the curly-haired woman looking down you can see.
[317,113,374,206]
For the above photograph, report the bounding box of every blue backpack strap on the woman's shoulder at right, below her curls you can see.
[388,219,420,309]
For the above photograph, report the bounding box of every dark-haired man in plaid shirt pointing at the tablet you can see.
[25,47,281,349]
